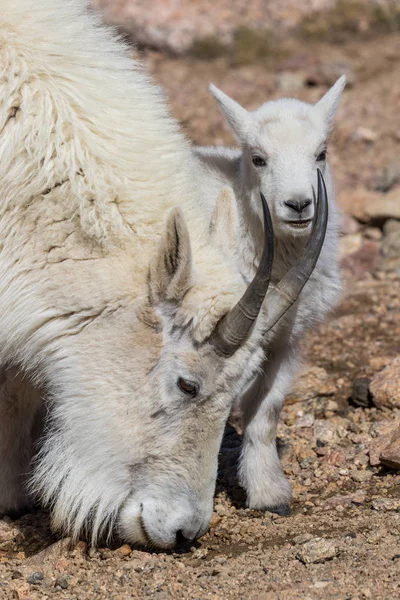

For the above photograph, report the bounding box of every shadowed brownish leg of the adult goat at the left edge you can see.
[0,369,42,516]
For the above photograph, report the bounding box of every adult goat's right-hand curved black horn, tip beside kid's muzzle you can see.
[265,169,328,333]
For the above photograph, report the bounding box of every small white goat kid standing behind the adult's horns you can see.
[197,76,345,512]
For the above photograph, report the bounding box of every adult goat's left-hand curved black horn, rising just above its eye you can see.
[210,194,274,356]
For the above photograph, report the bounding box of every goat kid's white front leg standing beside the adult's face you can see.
[239,356,294,515]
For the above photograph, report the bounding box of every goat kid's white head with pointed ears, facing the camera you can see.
[210,76,346,237]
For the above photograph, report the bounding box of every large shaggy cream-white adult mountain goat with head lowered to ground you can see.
[0,0,327,547]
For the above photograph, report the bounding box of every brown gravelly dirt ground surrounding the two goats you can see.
[0,34,400,600]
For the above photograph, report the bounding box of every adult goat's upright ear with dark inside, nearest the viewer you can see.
[148,208,192,304]
